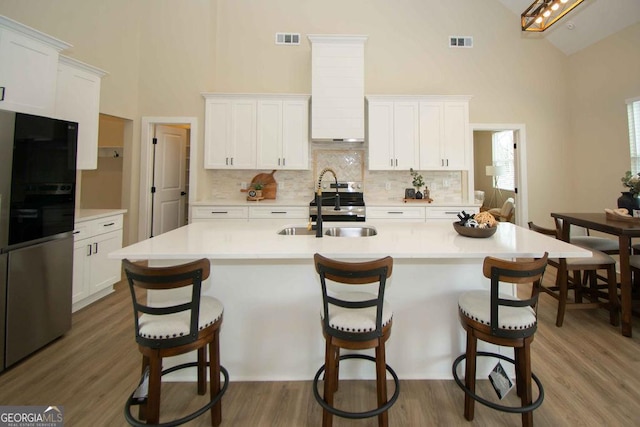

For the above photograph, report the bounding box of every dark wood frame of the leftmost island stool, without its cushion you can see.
[123,258,229,427]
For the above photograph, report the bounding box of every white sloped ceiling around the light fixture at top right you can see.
[498,0,640,55]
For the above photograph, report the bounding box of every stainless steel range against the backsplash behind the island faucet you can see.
[309,181,366,222]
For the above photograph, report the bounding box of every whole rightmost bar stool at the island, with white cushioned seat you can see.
[452,252,548,426]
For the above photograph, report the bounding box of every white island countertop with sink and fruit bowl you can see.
[109,220,590,260]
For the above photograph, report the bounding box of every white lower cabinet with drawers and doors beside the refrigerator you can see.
[72,214,122,311]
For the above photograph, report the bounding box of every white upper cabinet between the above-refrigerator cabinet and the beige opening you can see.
[55,55,106,169]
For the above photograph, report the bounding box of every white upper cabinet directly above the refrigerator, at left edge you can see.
[0,16,71,117]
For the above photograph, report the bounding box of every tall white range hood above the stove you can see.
[308,35,367,142]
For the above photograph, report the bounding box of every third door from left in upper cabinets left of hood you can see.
[257,99,283,169]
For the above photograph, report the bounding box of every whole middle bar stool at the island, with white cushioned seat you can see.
[313,254,400,427]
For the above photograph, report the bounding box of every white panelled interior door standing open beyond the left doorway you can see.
[151,125,187,236]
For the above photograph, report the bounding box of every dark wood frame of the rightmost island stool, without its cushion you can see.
[452,253,548,426]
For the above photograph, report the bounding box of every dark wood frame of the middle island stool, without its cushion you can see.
[313,254,400,427]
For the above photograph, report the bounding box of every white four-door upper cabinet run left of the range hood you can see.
[203,93,309,169]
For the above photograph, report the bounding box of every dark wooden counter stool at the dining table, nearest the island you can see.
[529,222,620,327]
